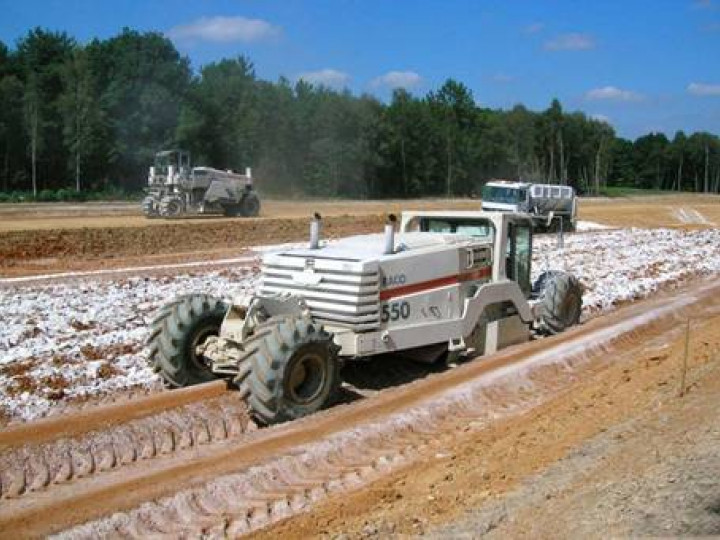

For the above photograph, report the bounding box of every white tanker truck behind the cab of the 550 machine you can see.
[481,180,577,232]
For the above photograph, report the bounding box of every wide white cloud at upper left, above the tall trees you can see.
[168,16,280,43]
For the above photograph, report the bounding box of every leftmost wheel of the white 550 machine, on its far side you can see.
[147,294,228,388]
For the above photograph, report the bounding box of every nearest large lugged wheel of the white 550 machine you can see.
[235,317,340,425]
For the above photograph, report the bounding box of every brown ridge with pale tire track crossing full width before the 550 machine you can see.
[0,285,720,538]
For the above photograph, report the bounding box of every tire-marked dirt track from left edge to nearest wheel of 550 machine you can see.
[0,381,254,499]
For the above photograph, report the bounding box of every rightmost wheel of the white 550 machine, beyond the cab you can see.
[533,271,582,334]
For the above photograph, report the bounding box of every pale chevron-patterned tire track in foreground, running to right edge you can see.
[40,280,720,538]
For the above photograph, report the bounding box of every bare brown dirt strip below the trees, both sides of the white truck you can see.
[0,195,720,277]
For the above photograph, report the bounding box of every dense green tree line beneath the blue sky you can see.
[0,28,720,198]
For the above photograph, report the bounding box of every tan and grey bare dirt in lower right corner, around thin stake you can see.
[255,292,720,539]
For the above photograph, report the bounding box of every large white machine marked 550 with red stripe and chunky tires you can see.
[148,212,582,424]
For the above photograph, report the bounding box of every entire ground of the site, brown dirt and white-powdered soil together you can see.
[0,195,720,538]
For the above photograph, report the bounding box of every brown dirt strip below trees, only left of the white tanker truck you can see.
[0,199,490,276]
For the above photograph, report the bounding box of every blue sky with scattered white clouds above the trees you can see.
[0,0,720,138]
